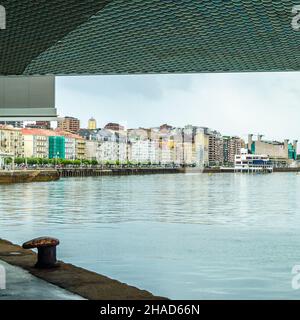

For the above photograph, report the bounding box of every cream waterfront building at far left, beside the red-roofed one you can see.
[0,126,24,157]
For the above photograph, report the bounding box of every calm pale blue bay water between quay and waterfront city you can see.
[0,173,300,299]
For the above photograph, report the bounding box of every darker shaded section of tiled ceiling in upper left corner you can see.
[0,0,109,75]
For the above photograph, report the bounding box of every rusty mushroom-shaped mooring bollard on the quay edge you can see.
[23,237,59,269]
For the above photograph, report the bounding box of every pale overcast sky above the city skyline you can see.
[56,73,300,147]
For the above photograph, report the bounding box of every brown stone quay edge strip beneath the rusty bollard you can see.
[0,239,168,300]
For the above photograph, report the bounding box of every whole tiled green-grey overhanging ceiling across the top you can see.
[0,0,300,75]
